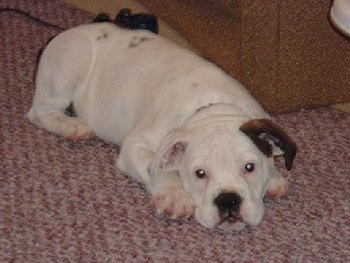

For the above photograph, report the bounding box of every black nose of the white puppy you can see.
[214,193,242,217]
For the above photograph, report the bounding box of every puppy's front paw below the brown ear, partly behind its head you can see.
[266,161,288,198]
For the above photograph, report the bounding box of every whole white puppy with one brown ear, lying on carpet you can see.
[28,23,297,233]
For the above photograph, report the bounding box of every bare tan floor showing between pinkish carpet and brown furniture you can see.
[64,0,350,113]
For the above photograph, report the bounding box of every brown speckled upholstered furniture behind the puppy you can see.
[140,0,350,113]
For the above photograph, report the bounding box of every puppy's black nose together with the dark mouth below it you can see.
[214,192,242,223]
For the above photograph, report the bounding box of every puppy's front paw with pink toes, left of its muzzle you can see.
[152,186,194,219]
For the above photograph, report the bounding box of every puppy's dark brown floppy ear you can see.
[240,119,297,171]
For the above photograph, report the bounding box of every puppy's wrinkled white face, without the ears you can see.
[179,130,269,228]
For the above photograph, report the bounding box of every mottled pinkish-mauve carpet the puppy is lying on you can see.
[0,0,350,263]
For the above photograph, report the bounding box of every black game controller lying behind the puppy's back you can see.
[93,8,158,34]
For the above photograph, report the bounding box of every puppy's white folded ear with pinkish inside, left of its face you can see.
[149,129,187,176]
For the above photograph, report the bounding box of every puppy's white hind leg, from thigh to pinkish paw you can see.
[28,32,93,140]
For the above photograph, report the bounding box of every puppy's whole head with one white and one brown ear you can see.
[150,118,296,231]
